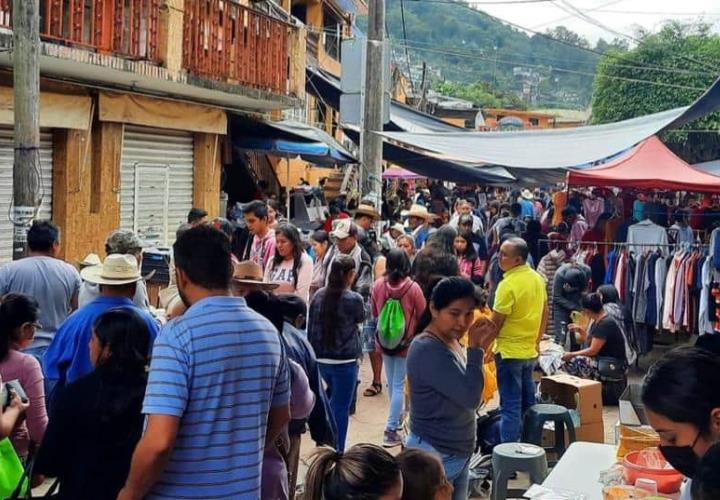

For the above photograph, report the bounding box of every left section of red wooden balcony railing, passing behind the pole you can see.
[0,0,160,62]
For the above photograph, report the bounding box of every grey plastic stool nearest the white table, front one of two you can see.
[491,443,547,500]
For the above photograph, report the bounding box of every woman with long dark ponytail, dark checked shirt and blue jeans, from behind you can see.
[308,255,365,452]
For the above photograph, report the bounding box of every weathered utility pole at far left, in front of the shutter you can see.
[12,0,40,260]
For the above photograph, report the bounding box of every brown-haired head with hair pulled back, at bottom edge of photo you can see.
[305,444,404,500]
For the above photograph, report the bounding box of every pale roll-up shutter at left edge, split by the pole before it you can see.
[0,127,53,264]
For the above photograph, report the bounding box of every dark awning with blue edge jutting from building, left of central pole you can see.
[230,115,357,166]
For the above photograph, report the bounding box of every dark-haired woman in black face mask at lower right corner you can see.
[642,347,720,500]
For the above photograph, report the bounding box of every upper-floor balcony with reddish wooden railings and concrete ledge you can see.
[0,0,305,111]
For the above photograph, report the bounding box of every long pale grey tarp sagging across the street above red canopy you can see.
[382,75,720,172]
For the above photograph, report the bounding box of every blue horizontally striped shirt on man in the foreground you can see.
[143,297,290,500]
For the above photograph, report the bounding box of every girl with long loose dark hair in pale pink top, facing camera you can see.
[265,224,313,302]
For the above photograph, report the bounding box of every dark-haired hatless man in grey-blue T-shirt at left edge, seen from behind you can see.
[0,220,81,359]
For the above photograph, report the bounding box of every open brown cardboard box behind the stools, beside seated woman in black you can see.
[540,373,603,424]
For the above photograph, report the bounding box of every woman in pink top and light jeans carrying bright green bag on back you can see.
[370,248,426,448]
